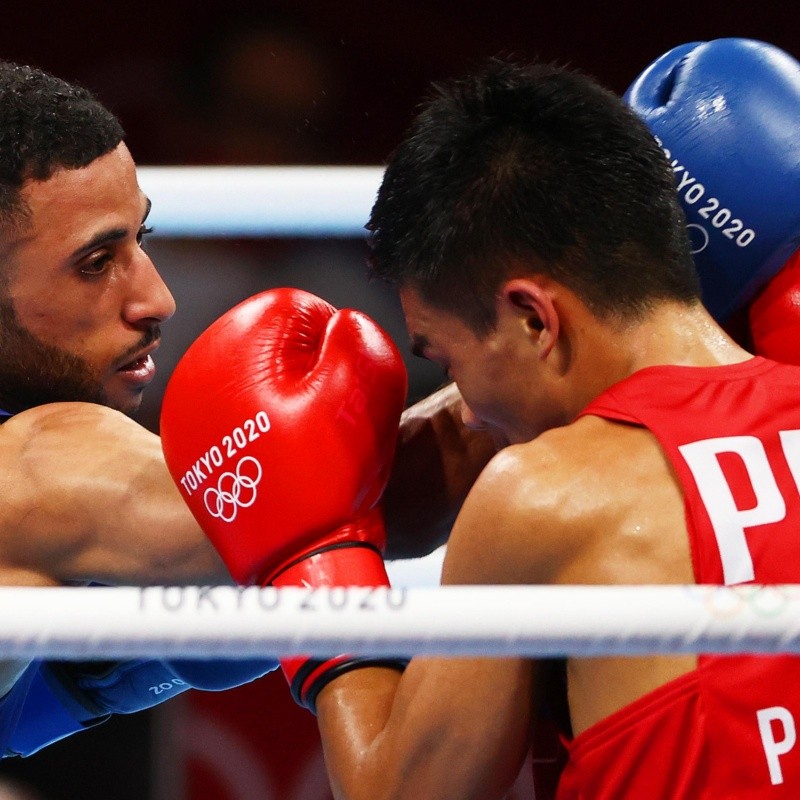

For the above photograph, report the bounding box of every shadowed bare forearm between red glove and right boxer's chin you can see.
[383,384,495,558]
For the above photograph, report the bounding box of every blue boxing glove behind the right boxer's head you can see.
[625,38,800,323]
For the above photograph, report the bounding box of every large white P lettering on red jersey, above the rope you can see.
[678,430,800,586]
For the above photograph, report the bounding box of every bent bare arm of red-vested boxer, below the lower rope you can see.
[317,658,531,800]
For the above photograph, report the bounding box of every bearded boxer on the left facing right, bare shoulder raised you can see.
[0,64,276,756]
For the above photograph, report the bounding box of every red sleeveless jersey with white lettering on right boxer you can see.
[557,358,800,800]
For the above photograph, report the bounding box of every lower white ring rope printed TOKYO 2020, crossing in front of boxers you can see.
[0,585,800,659]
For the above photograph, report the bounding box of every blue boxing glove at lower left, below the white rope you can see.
[0,659,278,757]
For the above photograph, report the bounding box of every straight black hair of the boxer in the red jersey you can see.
[366,58,700,332]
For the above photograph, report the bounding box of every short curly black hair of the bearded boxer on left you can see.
[0,61,125,227]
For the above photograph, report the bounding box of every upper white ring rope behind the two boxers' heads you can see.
[137,166,383,237]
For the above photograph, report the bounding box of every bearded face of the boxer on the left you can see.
[0,144,175,413]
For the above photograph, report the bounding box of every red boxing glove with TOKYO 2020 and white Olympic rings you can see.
[161,289,407,710]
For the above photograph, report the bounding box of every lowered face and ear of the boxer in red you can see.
[400,286,562,446]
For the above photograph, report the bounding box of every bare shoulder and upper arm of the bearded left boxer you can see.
[0,403,230,585]
